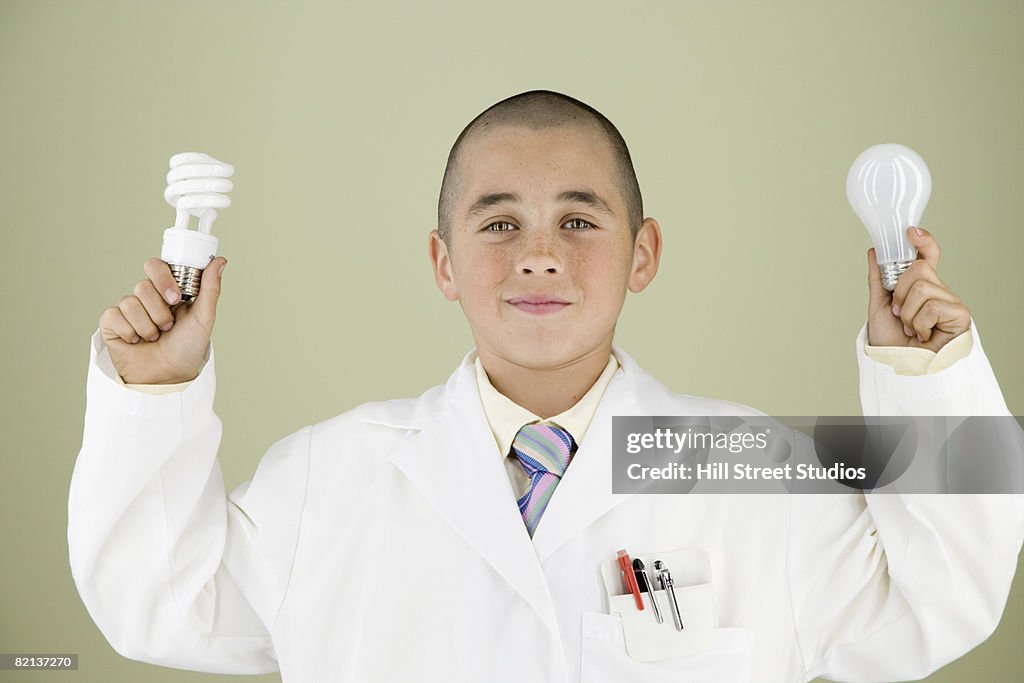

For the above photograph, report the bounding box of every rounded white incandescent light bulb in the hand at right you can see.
[846,142,932,292]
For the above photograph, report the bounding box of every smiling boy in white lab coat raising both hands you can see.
[69,91,1022,682]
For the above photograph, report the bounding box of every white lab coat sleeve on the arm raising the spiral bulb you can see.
[68,332,311,674]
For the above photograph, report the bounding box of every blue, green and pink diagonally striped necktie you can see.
[512,424,575,539]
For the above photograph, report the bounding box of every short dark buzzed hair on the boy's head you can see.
[437,90,643,248]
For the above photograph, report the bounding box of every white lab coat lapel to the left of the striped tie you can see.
[391,353,558,637]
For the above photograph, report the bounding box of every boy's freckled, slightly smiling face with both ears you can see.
[430,126,660,369]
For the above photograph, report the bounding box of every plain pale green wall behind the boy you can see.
[0,0,1024,681]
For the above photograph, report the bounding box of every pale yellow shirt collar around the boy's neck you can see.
[473,353,620,458]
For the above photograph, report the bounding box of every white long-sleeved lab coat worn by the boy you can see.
[69,321,1024,683]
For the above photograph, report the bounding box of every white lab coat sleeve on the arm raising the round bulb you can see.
[787,323,1024,681]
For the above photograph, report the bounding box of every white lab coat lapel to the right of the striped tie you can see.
[534,347,656,562]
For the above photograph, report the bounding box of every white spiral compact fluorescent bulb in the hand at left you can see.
[160,152,234,301]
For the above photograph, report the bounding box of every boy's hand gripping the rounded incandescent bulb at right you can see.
[867,227,971,351]
